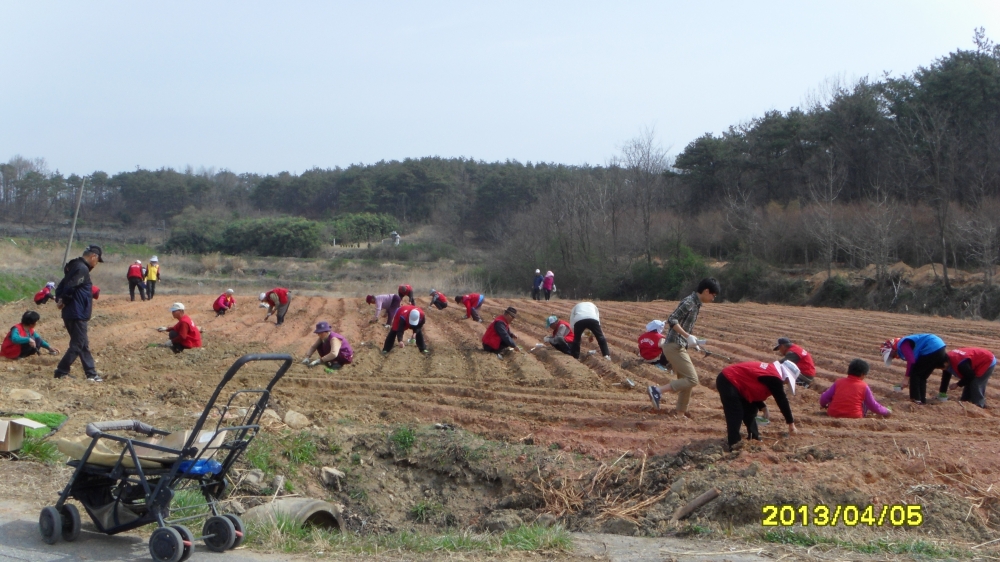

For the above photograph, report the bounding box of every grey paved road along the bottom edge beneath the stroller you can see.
[0,501,773,562]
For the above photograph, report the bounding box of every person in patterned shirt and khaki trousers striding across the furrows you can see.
[646,277,722,417]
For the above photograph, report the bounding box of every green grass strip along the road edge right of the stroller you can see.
[246,517,572,555]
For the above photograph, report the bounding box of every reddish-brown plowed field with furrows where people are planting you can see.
[0,295,1000,543]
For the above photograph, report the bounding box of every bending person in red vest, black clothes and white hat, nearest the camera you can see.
[715,361,799,451]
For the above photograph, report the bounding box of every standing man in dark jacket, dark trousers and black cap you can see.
[55,245,104,382]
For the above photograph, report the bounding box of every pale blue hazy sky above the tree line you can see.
[0,0,1000,175]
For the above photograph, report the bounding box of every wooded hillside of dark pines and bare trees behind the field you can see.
[0,29,1000,298]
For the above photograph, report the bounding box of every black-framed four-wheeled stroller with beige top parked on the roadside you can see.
[38,354,292,562]
